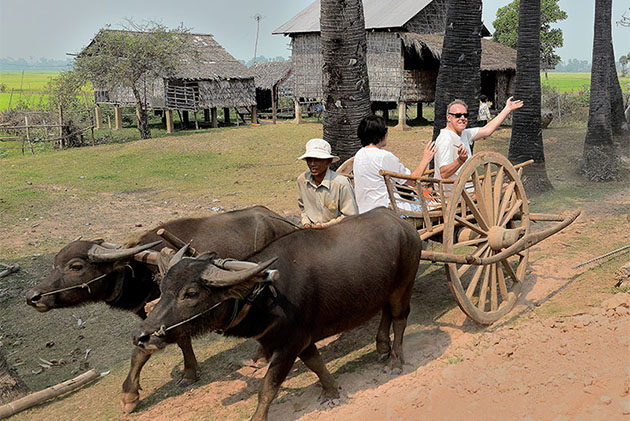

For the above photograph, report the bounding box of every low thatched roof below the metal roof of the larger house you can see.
[400,33,516,71]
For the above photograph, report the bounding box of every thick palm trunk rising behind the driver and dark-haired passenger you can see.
[320,0,370,166]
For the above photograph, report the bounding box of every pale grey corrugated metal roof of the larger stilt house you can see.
[273,0,432,35]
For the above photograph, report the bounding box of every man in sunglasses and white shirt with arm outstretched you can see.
[434,97,523,179]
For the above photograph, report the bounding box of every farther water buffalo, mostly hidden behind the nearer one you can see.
[26,206,295,412]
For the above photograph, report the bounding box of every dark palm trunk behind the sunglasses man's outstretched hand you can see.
[508,0,553,193]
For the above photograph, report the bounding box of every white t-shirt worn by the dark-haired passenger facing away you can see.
[352,147,411,213]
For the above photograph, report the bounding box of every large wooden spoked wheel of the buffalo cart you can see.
[444,152,530,324]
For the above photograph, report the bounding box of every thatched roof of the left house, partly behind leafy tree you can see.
[81,29,253,80]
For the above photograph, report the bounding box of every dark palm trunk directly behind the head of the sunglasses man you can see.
[433,0,483,140]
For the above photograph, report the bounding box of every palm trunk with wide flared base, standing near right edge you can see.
[580,0,619,181]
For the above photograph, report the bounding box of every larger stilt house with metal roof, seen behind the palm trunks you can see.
[273,0,516,128]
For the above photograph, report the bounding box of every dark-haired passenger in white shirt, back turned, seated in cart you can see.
[353,115,435,213]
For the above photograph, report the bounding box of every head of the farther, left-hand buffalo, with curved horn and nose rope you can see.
[26,240,159,312]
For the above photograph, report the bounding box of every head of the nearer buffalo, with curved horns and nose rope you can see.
[132,253,278,352]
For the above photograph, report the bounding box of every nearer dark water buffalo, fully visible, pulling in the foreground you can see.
[132,208,421,420]
